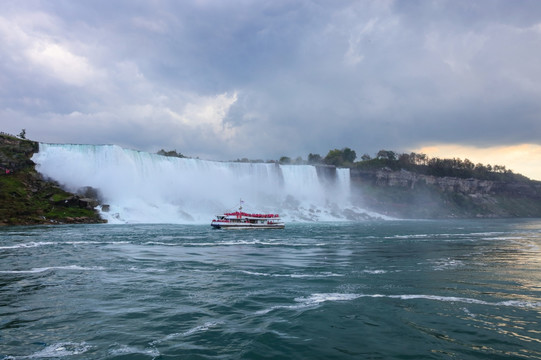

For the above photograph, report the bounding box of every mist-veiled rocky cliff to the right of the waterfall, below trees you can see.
[351,169,541,218]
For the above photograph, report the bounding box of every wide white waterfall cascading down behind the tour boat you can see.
[32,144,376,223]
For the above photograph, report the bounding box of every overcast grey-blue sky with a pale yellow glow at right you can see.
[0,0,541,179]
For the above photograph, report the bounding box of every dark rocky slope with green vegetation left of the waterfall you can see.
[0,134,104,225]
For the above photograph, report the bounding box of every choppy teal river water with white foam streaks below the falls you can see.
[0,220,541,359]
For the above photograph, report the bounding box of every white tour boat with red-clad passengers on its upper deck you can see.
[210,200,285,229]
